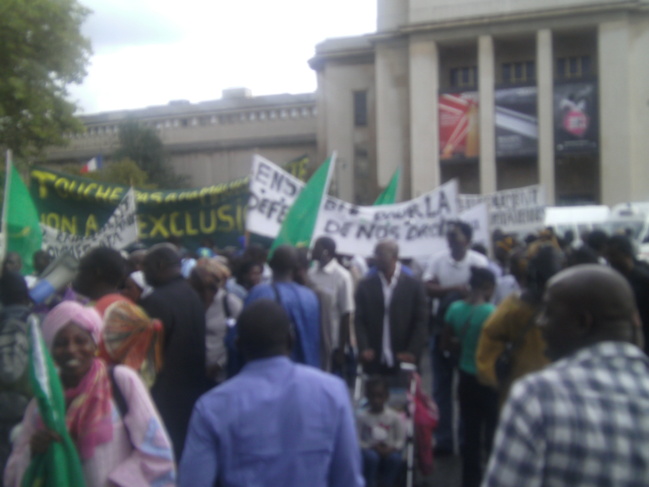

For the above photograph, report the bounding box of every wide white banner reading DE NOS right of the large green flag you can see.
[313,180,458,258]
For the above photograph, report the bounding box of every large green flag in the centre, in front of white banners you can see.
[270,155,335,254]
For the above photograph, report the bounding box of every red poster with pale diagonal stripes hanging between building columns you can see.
[439,91,480,161]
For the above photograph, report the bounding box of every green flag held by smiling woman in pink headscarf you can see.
[22,315,86,487]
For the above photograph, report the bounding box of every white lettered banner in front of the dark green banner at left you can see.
[41,188,138,259]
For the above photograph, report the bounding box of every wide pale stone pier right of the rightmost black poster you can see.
[597,20,632,205]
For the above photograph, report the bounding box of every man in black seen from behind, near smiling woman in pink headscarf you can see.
[141,244,210,460]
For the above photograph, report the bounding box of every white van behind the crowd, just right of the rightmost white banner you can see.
[545,205,611,246]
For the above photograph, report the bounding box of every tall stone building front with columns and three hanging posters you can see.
[310,0,649,205]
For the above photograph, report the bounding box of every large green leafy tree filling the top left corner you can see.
[0,0,91,157]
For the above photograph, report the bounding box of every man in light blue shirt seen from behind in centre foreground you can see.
[179,299,364,487]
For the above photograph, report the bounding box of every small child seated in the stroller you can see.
[356,377,406,487]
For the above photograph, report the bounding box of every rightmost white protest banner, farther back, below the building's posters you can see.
[458,184,545,234]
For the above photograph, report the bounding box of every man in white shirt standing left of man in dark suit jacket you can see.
[309,237,354,378]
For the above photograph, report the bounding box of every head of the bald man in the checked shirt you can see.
[538,264,639,360]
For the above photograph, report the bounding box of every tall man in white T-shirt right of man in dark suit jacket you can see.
[423,221,489,454]
